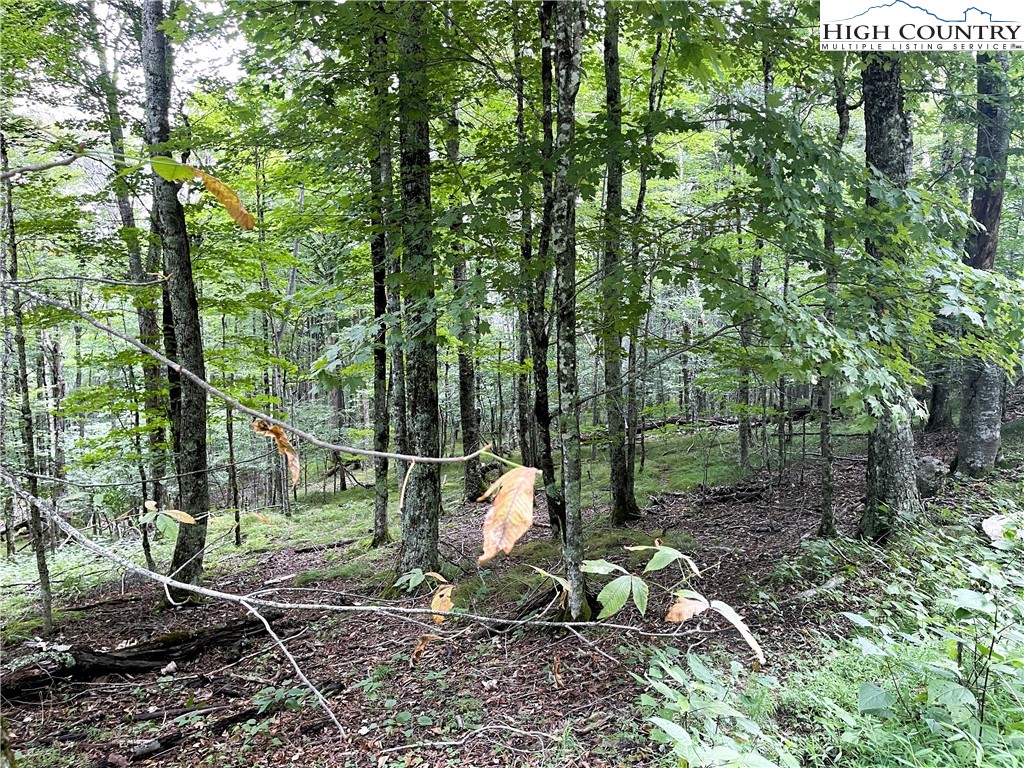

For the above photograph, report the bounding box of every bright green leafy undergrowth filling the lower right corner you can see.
[644,454,1024,768]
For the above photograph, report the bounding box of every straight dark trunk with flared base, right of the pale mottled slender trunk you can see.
[598,0,640,525]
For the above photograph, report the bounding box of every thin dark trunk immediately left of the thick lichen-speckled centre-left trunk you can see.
[372,12,391,547]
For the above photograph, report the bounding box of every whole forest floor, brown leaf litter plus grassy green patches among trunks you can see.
[0,414,1016,768]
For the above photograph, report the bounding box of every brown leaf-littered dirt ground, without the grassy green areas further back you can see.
[4,423,954,768]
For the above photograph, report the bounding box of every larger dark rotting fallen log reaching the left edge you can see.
[0,613,281,700]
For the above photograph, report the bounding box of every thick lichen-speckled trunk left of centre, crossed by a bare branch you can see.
[398,3,440,572]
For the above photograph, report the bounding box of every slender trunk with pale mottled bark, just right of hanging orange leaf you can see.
[551,0,586,618]
